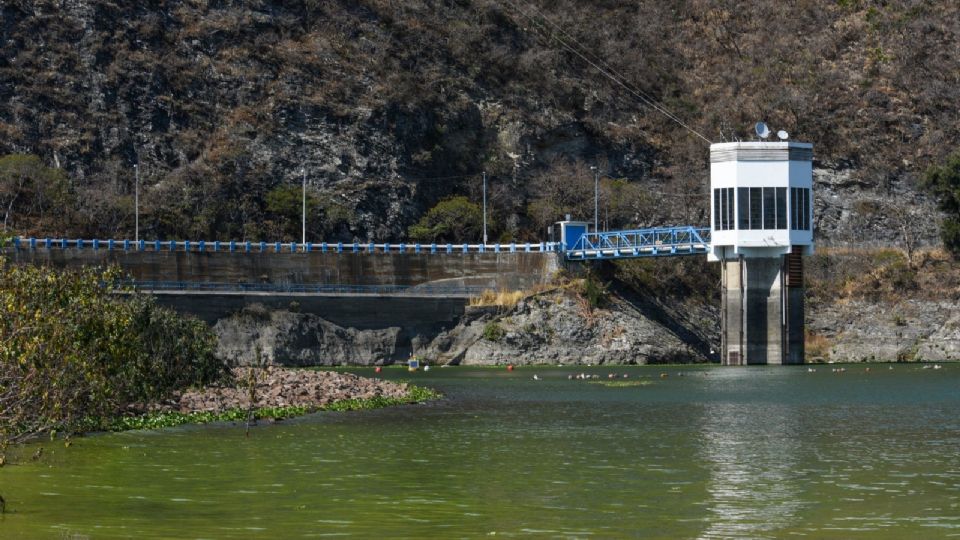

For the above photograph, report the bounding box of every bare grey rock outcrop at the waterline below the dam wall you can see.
[214,290,718,366]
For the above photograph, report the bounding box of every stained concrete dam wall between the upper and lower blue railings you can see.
[5,247,558,290]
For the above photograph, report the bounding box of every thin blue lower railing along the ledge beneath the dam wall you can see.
[120,281,490,297]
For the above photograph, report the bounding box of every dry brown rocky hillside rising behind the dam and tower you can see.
[0,0,960,244]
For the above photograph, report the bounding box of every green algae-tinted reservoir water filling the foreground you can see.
[0,365,960,539]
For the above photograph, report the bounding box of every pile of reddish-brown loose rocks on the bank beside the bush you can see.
[169,366,408,413]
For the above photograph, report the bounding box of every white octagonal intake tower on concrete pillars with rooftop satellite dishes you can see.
[708,139,813,365]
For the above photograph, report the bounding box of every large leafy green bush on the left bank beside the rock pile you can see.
[0,260,225,440]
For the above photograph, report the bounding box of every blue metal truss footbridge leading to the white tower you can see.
[564,226,710,260]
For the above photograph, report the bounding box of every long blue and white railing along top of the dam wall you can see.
[13,237,559,254]
